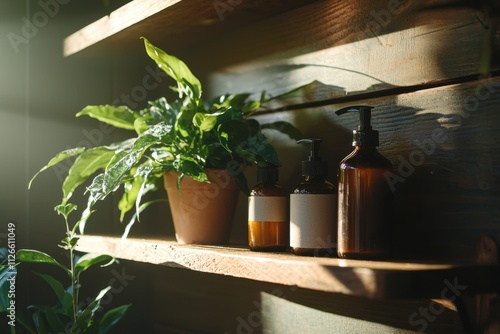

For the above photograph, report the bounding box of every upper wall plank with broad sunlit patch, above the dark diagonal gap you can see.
[198,0,487,101]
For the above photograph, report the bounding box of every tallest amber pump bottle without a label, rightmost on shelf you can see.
[336,106,393,259]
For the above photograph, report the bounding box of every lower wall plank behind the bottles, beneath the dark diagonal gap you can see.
[248,77,500,261]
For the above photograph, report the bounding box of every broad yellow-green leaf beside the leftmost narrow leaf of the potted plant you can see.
[62,146,115,203]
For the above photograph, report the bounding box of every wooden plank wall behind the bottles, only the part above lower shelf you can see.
[178,0,500,261]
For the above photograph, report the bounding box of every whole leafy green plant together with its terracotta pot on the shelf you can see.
[30,39,300,244]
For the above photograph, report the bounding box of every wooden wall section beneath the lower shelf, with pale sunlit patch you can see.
[114,261,463,334]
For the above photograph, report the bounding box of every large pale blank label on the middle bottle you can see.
[290,194,337,249]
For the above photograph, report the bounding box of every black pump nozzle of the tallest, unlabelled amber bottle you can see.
[335,106,379,147]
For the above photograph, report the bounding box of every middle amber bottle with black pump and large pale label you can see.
[290,139,337,257]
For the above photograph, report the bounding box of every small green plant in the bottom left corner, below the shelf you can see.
[0,203,130,334]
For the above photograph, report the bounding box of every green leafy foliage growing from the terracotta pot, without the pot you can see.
[29,38,301,233]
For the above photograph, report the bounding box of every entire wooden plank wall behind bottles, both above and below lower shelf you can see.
[97,0,500,333]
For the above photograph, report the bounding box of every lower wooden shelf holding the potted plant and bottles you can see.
[77,236,500,299]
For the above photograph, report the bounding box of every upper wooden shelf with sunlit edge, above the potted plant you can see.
[63,0,313,56]
